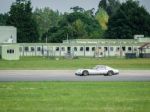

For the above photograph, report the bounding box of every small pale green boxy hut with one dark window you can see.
[1,45,20,60]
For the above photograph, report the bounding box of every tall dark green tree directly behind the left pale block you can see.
[7,0,38,43]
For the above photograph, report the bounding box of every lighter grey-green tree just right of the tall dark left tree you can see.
[33,7,62,40]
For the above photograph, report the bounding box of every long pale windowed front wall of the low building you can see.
[17,44,142,57]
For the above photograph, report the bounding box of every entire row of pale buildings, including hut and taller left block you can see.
[0,26,150,60]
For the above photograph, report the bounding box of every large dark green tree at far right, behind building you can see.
[105,0,150,39]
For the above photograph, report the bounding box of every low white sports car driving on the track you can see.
[75,65,119,76]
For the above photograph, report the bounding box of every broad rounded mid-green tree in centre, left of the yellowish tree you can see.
[42,7,103,42]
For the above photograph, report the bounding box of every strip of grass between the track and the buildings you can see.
[0,57,150,70]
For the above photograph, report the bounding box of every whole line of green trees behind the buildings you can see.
[0,0,150,43]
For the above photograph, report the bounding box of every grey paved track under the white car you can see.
[0,70,150,81]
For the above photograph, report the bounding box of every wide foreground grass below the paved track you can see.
[0,82,150,112]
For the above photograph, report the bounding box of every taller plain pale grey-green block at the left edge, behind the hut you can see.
[0,26,17,43]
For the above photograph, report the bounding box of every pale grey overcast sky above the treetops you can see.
[0,0,150,13]
